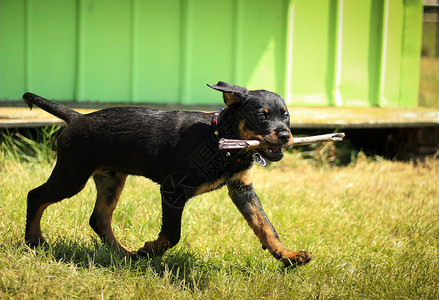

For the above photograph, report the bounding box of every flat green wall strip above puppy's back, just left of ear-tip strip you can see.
[132,0,182,103]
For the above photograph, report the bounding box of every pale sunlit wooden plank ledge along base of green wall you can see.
[0,107,439,128]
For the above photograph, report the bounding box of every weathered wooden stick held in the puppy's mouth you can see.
[218,132,345,149]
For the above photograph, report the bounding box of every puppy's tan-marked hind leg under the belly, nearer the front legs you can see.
[90,170,133,255]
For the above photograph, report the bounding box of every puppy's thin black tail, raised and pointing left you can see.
[23,93,82,123]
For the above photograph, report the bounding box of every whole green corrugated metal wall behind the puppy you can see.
[0,0,422,107]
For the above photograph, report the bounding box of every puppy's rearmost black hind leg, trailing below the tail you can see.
[25,157,92,247]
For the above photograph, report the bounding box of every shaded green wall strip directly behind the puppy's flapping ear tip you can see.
[181,0,234,104]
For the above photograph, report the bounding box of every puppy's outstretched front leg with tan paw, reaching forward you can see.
[227,180,311,266]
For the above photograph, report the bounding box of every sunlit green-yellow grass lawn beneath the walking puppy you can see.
[0,144,439,299]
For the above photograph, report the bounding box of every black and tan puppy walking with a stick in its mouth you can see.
[23,81,311,265]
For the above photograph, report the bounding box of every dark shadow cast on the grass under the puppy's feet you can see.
[17,238,295,291]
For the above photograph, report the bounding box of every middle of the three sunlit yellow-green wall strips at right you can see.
[335,0,381,106]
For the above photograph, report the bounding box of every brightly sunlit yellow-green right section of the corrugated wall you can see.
[286,0,422,107]
